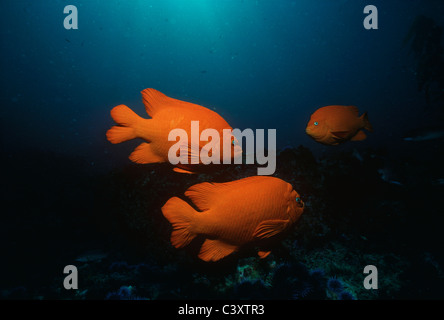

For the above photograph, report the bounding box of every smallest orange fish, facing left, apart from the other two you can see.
[305,106,373,145]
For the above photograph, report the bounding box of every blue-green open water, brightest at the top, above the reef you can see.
[0,0,443,167]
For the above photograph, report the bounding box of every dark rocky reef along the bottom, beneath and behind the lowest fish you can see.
[1,146,444,300]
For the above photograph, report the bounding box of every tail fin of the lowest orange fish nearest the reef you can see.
[162,197,198,248]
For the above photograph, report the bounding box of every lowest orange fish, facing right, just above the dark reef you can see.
[162,176,304,261]
